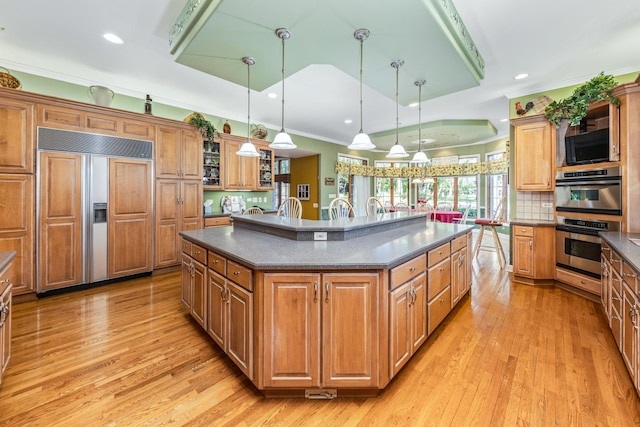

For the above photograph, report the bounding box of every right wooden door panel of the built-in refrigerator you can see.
[107,158,152,277]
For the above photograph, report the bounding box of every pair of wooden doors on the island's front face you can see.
[263,273,378,388]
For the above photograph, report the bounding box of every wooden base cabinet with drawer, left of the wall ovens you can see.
[512,224,556,284]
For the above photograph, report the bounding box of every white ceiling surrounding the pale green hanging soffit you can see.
[0,0,640,155]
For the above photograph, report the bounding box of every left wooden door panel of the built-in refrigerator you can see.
[37,152,83,292]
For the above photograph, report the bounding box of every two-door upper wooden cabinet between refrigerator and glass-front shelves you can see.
[154,126,202,180]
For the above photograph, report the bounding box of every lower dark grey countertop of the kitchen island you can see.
[180,220,473,270]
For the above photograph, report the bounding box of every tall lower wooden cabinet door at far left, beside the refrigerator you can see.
[0,174,35,295]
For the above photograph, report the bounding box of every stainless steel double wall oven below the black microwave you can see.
[556,166,622,278]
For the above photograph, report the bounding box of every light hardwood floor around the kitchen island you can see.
[0,252,640,427]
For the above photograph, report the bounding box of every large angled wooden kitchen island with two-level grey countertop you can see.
[181,213,472,398]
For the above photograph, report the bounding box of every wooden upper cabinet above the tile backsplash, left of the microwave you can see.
[511,115,556,191]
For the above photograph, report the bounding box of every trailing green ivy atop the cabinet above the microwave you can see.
[544,72,620,127]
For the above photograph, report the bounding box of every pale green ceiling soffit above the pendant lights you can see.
[169,0,484,105]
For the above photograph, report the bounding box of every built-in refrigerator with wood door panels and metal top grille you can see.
[36,127,153,293]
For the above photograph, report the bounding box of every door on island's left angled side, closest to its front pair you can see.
[226,282,253,379]
